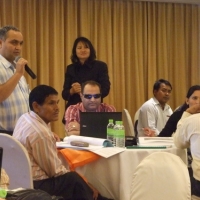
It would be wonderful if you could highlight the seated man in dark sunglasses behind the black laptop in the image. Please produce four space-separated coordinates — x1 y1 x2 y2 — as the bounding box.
65 81 116 135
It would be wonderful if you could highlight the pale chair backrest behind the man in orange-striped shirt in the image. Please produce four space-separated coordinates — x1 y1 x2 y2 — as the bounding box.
0 133 33 189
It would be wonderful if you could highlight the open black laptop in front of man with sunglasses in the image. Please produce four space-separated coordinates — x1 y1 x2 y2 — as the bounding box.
80 112 122 139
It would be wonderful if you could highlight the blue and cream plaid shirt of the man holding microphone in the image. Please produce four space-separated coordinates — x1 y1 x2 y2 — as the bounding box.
0 55 30 131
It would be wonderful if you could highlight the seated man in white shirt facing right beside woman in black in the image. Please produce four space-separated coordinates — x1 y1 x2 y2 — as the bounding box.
137 79 172 137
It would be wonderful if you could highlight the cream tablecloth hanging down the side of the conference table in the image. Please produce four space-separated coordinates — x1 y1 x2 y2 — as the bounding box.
76 147 187 200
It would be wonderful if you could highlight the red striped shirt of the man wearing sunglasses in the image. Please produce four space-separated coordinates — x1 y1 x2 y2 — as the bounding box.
65 103 116 129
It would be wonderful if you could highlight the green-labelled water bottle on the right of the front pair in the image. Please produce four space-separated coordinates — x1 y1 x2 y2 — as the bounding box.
115 121 125 148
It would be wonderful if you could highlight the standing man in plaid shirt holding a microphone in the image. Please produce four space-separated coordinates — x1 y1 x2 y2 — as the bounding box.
0 26 30 135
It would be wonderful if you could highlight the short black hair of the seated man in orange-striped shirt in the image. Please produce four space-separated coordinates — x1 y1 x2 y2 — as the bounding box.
29 85 58 111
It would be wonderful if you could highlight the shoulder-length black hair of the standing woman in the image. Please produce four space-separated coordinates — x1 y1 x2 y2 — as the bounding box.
71 37 96 63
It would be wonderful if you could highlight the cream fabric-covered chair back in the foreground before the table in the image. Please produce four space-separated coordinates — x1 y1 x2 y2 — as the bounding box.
130 152 191 200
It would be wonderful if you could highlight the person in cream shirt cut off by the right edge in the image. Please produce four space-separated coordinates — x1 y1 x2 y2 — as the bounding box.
173 104 200 197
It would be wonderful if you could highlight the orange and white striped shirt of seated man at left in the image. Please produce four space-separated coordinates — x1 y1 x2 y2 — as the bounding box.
13 111 68 181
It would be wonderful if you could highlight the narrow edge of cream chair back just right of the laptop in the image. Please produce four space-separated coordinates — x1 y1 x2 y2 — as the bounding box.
122 109 135 136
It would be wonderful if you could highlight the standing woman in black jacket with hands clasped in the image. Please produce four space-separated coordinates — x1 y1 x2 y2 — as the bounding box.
62 37 110 118
